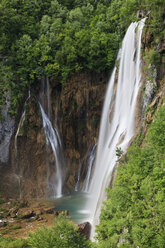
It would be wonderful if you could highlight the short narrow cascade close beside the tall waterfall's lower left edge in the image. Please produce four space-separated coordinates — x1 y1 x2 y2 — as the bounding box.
82 144 97 192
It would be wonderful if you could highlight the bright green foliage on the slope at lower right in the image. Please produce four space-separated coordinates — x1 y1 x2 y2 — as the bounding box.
97 106 165 248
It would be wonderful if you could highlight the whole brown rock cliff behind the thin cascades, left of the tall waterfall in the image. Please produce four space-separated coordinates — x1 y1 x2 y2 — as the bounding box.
0 71 108 198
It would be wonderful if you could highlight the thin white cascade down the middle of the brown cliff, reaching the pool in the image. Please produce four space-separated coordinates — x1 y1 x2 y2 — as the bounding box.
39 103 62 197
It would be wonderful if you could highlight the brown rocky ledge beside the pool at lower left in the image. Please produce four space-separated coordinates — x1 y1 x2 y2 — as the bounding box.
0 199 68 238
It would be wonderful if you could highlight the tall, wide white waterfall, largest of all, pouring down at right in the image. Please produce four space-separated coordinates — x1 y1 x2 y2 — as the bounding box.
87 19 145 235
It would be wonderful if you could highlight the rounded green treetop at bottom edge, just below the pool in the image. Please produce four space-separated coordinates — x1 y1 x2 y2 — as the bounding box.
28 216 91 248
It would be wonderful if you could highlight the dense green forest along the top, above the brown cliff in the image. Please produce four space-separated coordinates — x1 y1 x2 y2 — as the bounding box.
0 0 164 114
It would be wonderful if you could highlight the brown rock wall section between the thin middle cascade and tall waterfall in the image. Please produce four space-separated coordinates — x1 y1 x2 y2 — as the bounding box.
55 71 108 190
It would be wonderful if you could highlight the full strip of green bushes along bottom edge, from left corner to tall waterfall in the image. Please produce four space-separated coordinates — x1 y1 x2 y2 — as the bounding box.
0 215 91 248
